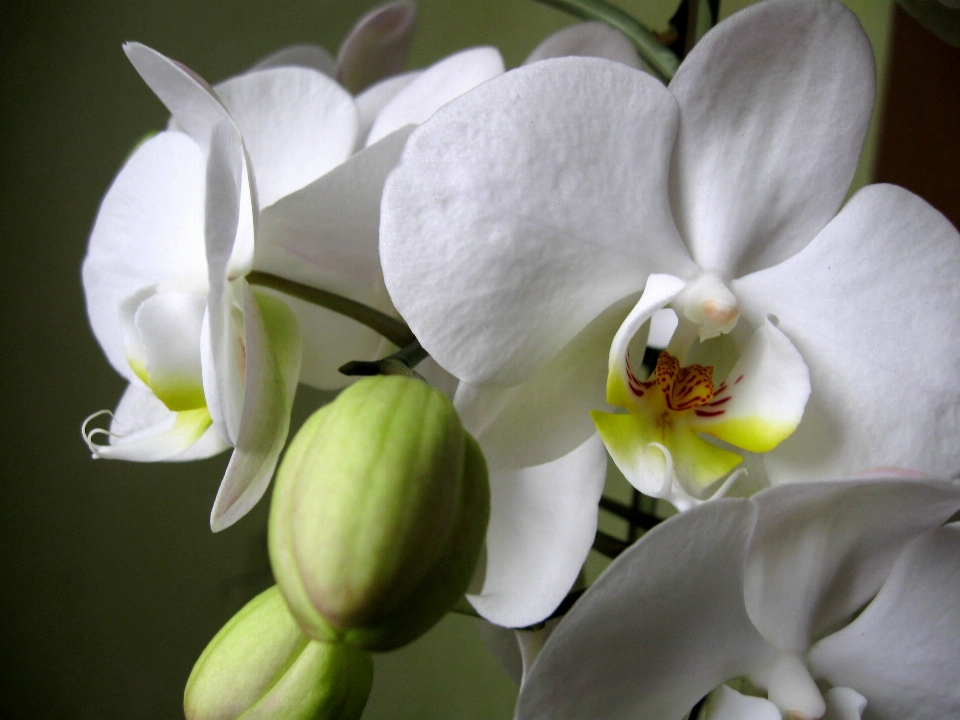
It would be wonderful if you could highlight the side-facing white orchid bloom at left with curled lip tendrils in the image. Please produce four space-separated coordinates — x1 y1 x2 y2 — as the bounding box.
83 3 503 530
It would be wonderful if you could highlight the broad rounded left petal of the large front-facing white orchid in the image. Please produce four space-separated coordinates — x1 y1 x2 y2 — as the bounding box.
380 58 694 384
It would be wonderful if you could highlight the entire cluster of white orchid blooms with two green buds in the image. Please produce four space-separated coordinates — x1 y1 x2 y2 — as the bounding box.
83 0 960 720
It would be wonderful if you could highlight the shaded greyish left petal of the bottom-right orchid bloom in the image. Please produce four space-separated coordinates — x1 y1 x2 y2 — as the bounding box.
517 500 769 720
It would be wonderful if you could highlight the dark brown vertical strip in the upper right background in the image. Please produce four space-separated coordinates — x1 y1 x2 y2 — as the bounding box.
876 6 960 227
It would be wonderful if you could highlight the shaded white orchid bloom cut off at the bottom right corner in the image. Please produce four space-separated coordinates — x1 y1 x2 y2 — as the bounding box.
517 477 960 720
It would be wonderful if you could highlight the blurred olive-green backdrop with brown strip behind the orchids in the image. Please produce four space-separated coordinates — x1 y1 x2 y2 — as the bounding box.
0 0 960 720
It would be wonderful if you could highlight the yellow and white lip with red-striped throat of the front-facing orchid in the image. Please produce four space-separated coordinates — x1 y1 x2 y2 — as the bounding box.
590 273 810 509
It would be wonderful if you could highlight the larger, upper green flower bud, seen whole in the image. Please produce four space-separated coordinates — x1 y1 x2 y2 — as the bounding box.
270 376 490 650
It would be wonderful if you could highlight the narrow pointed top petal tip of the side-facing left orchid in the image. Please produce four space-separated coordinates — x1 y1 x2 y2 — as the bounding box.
123 42 230 152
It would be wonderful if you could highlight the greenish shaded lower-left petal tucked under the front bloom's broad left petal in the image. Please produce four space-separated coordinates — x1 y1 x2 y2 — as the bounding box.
455 298 632 471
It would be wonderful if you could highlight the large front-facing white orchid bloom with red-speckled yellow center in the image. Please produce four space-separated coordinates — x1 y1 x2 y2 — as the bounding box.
380 0 960 625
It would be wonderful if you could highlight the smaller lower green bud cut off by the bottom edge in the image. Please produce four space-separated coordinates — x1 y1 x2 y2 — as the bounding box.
183 586 373 720
